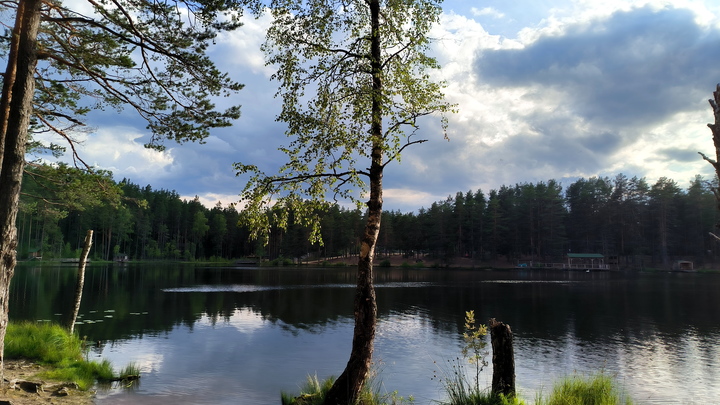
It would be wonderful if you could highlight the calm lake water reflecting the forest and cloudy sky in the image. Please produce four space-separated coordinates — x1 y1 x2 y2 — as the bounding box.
10 264 720 405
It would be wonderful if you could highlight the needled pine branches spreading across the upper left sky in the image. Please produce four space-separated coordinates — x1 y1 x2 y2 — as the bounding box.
0 0 250 158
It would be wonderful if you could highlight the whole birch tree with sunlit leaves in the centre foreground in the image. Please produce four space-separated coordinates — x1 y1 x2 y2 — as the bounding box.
236 0 452 404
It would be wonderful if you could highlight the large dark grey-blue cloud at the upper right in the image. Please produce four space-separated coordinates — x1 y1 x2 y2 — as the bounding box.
474 7 720 126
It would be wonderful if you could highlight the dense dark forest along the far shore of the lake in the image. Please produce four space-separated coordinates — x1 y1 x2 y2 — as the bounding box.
17 166 720 267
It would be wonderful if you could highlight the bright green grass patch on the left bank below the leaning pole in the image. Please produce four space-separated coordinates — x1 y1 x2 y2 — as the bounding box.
5 322 139 390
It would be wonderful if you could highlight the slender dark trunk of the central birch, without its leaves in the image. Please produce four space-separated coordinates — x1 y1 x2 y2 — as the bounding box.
325 0 384 405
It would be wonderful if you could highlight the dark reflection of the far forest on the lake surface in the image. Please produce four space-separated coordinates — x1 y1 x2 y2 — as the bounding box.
10 264 720 347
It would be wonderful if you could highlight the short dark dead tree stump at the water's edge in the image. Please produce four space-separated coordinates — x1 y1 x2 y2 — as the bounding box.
488 318 515 396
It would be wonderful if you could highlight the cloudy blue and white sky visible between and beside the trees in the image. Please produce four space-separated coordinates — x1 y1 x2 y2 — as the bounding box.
64 0 720 212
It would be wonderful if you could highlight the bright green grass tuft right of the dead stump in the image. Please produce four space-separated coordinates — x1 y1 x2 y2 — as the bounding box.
535 373 632 405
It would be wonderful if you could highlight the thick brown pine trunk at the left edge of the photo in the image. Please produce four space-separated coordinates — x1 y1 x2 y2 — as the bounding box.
0 0 42 381
